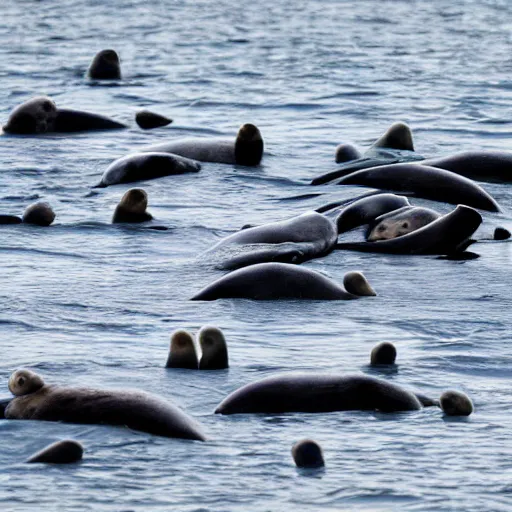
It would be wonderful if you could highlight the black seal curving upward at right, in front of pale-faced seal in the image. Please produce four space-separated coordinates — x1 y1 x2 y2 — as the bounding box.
336 205 482 255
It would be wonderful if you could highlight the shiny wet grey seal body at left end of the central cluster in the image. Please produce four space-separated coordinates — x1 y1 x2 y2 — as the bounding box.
206 212 338 270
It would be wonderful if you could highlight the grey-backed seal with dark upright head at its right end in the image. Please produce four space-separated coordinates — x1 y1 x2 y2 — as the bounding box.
143 124 263 166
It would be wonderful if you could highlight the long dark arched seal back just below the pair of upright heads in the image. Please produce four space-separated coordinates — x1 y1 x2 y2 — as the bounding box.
215 373 436 414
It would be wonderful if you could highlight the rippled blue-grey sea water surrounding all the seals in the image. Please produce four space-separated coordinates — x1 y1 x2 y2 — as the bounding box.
0 0 512 511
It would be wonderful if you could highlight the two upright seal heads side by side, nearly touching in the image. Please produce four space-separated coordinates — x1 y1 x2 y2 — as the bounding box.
165 326 229 370
